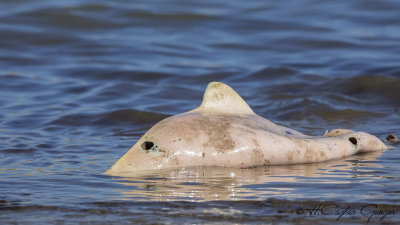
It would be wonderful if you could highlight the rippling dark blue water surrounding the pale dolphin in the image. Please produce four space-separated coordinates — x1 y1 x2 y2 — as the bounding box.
0 0 400 224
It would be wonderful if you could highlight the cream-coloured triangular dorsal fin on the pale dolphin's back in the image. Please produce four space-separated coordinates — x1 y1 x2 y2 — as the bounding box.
193 82 254 114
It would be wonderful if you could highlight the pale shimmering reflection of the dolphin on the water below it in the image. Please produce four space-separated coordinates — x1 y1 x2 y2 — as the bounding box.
113 152 382 202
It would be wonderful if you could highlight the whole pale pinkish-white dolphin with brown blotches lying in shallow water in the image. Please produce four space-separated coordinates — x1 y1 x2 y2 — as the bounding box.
107 82 387 174
